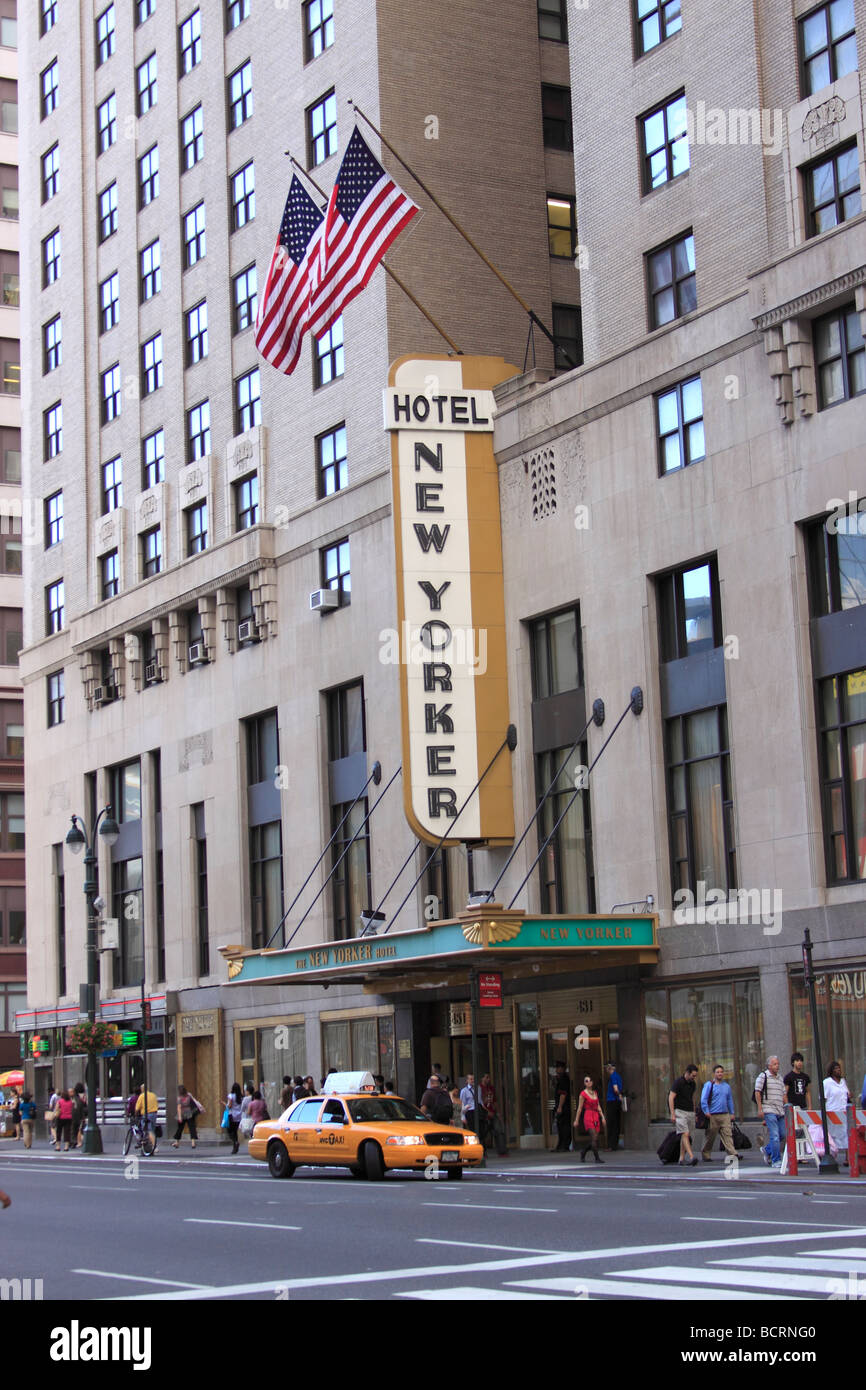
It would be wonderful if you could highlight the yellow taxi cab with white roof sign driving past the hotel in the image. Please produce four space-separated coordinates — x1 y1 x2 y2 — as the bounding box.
249 1072 484 1182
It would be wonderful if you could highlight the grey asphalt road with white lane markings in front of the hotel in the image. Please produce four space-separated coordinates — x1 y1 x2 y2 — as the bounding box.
0 1152 866 1301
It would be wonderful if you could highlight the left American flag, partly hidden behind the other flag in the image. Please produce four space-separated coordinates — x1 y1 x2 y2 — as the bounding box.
256 174 324 375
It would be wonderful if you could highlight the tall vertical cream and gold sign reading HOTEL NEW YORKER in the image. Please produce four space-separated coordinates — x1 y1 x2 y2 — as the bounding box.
385 357 516 844
